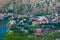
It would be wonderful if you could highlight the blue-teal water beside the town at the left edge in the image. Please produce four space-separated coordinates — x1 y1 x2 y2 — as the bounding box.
0 19 8 40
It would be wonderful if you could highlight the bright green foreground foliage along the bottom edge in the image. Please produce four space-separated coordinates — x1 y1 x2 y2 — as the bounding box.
5 31 60 40
